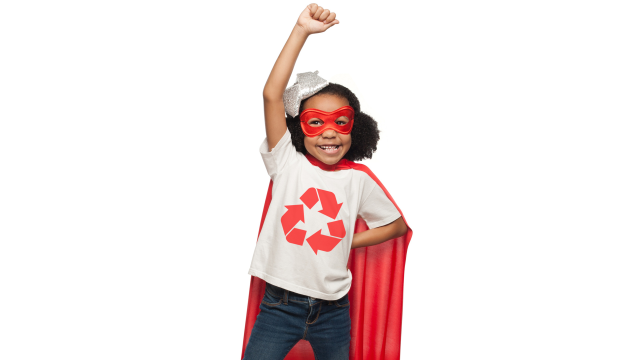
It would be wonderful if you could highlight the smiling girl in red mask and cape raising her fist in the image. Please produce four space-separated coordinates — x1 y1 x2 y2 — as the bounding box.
242 4 412 360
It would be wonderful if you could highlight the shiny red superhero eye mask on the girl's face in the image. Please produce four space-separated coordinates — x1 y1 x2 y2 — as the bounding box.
300 105 355 137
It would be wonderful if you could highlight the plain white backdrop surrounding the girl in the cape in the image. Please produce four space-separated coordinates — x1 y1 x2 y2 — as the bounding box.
0 0 640 360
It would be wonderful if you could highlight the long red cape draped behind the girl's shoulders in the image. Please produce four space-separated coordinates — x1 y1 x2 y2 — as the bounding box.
241 154 413 360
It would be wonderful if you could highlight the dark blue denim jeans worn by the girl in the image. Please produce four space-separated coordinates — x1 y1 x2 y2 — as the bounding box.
242 283 351 360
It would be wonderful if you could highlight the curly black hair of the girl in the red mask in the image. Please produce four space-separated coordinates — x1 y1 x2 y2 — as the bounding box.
287 83 380 161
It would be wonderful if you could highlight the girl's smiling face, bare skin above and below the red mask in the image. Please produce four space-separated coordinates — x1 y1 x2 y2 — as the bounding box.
300 94 351 165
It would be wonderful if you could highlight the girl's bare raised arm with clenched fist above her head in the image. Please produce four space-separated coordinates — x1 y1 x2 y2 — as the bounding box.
262 4 339 151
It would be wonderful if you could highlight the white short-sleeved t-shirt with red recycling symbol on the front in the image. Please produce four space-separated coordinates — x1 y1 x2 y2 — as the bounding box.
249 129 401 300
